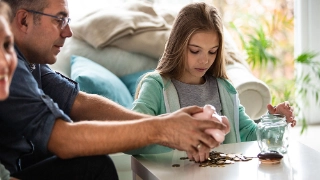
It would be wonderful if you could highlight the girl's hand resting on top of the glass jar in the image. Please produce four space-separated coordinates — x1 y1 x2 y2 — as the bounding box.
267 101 297 127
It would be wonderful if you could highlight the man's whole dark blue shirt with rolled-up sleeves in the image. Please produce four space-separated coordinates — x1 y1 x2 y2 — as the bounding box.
0 47 79 173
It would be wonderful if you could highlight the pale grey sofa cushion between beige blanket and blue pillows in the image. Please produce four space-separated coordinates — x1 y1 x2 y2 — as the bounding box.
50 37 158 77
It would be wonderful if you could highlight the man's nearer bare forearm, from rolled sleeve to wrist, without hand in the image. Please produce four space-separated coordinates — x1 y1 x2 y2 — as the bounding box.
48 119 161 158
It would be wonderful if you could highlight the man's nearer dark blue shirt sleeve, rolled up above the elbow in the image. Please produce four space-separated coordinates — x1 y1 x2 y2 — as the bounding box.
0 60 72 154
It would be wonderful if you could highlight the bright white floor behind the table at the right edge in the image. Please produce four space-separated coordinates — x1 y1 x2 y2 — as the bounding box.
289 124 320 152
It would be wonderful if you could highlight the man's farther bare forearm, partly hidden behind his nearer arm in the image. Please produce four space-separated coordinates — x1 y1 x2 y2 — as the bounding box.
70 92 149 121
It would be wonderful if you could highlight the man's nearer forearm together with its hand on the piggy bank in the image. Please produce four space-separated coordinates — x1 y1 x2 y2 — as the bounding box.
48 106 226 158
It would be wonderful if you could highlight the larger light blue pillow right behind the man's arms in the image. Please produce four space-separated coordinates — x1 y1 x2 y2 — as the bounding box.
71 56 133 109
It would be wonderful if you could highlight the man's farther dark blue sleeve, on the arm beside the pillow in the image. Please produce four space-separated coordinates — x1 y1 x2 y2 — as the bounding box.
40 65 79 115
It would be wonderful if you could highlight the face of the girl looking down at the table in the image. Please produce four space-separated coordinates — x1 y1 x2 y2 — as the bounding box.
179 31 219 84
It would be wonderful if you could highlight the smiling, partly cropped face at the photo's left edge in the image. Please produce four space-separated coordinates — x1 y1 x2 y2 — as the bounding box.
0 15 17 100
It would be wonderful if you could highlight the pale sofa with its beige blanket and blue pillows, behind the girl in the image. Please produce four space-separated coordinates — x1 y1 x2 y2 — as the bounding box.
50 2 271 179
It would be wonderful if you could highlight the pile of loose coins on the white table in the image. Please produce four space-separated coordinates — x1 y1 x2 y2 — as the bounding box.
173 151 253 167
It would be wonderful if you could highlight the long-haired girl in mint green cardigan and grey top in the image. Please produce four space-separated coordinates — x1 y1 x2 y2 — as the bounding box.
129 3 295 161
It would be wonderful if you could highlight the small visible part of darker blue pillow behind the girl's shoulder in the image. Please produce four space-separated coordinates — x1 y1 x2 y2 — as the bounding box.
120 70 154 98
